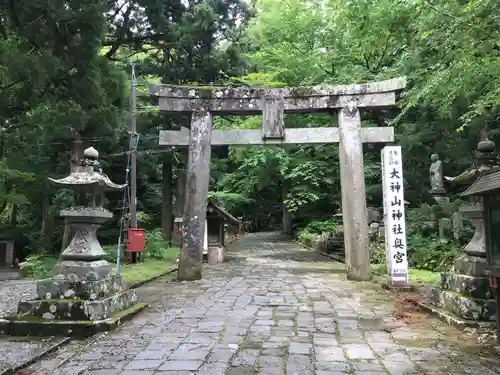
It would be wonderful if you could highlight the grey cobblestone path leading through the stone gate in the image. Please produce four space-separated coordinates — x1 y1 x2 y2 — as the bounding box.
19 233 500 375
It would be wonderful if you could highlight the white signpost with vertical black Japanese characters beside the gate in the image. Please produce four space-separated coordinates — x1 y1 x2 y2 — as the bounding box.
382 146 408 286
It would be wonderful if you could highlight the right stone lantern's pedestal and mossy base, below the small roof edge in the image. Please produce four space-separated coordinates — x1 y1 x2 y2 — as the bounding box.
427 202 497 322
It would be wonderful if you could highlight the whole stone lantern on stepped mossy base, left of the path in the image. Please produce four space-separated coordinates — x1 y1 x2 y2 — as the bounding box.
0 147 146 335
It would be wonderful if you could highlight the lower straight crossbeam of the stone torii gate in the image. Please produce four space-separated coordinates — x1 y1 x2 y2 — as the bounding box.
159 127 394 146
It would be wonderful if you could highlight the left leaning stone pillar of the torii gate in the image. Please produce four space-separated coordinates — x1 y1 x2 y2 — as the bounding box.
177 109 212 281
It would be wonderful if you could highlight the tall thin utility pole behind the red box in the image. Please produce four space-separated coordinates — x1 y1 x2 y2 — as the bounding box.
130 63 139 228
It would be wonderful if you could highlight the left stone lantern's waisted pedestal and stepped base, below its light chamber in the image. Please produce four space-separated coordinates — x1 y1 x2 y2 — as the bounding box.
0 208 146 336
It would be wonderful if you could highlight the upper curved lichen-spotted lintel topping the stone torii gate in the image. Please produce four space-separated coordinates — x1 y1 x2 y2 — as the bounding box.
149 78 406 116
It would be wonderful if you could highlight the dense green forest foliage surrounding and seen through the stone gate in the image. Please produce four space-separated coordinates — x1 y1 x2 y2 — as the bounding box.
0 0 500 276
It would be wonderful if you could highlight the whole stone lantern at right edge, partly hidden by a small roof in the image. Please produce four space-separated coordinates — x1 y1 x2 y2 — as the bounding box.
428 136 497 321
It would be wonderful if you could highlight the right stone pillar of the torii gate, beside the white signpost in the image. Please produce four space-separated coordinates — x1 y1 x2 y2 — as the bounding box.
338 107 371 281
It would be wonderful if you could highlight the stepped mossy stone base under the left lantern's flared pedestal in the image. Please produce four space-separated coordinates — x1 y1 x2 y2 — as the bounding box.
0 277 146 336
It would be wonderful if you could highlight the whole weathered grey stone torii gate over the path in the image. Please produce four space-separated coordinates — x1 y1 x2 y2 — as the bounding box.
150 78 406 280
